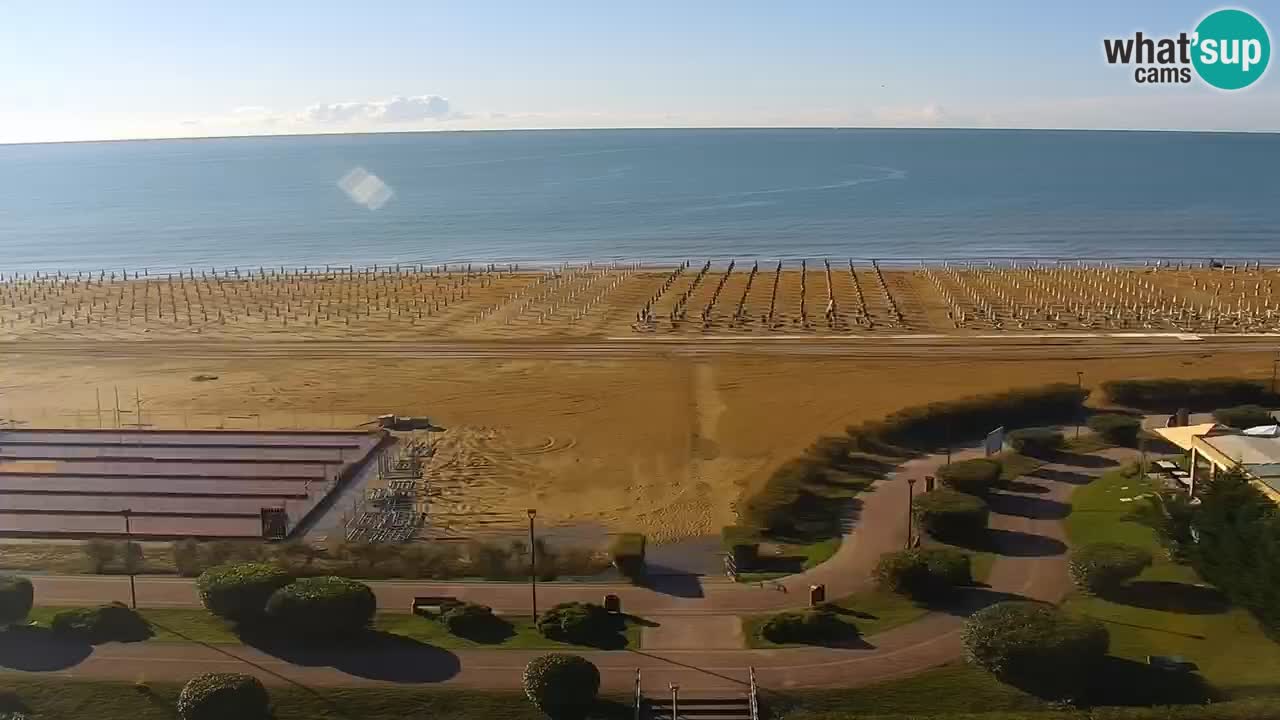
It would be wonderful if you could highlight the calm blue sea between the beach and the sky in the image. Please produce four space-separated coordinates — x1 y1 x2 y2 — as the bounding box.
0 129 1280 272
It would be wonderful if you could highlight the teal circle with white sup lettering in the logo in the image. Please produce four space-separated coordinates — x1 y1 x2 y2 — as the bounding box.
1192 10 1271 90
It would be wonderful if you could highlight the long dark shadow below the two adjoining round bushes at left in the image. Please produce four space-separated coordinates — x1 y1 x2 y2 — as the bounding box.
241 630 461 684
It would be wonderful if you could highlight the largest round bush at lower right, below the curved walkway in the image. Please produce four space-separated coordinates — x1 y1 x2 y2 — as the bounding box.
960 601 1110 694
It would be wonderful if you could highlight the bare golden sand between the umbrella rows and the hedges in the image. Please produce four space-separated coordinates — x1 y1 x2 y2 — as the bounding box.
0 345 1270 539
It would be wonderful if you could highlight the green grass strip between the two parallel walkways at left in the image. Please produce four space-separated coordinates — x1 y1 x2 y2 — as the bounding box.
29 607 641 650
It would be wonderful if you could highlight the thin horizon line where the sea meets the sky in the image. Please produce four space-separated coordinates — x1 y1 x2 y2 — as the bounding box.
0 126 1280 147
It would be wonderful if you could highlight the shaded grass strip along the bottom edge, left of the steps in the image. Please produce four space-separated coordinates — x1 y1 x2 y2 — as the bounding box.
5 676 631 720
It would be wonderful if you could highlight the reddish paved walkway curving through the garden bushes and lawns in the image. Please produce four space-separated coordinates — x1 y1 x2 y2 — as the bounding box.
0 450 1135 692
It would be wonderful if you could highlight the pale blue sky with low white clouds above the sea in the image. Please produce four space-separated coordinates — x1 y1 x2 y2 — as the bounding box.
0 0 1280 142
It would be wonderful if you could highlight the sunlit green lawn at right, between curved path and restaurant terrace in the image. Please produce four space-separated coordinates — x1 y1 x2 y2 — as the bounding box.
1065 471 1280 697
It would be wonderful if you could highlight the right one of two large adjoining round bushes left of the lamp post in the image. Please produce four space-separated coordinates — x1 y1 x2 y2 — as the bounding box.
266 575 378 642
